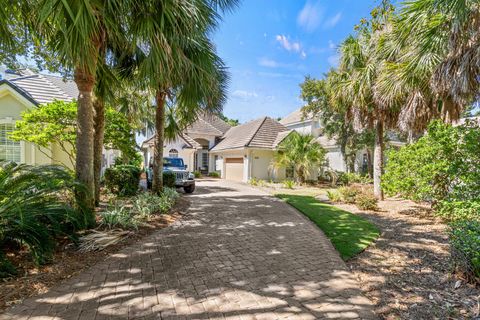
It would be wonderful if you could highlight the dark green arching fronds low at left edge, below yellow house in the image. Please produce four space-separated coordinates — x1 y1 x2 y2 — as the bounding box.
0 162 85 264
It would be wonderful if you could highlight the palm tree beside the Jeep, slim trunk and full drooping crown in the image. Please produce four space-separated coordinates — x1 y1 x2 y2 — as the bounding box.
131 0 237 193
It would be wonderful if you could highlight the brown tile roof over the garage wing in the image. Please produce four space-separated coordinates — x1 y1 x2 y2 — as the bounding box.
211 117 288 151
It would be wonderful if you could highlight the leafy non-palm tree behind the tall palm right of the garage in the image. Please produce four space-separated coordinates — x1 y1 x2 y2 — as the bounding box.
300 75 373 172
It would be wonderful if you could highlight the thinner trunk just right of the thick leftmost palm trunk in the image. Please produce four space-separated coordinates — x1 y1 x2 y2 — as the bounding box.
93 97 105 205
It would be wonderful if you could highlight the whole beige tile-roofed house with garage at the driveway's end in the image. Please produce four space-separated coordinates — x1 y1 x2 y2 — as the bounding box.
142 115 289 182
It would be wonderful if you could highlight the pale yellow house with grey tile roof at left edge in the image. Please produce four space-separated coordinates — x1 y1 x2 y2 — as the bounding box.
0 67 118 168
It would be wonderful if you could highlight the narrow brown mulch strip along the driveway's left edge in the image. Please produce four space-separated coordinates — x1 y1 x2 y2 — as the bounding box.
0 197 190 311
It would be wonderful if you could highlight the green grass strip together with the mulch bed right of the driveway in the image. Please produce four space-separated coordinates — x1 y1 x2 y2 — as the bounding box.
253 182 480 319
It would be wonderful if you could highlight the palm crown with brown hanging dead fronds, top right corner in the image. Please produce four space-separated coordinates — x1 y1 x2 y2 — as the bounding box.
397 0 480 115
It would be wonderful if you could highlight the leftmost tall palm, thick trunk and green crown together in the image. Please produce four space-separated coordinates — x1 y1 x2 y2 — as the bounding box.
31 0 130 209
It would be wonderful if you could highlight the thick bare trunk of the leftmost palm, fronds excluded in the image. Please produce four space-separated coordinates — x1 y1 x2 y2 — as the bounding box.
74 68 95 219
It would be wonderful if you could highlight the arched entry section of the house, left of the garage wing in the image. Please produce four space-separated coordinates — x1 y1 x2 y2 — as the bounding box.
142 114 230 174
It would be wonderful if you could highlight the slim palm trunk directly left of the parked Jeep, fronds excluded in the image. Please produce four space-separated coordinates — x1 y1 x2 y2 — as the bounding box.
152 89 167 194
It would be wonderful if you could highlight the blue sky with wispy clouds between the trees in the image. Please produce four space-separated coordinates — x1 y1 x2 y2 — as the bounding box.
214 0 376 123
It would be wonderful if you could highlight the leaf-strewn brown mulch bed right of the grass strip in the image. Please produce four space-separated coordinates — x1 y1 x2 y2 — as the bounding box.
338 199 480 320
